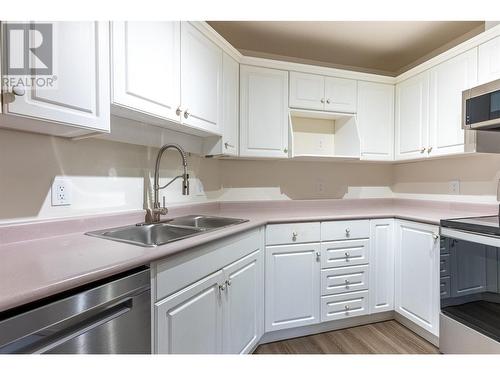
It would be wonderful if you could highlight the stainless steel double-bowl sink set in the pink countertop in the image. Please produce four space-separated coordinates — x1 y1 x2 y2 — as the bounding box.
85 215 248 247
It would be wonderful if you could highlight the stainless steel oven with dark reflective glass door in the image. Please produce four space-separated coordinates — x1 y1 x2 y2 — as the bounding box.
439 216 500 354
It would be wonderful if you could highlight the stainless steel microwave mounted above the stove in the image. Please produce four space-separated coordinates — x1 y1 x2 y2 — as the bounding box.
462 79 500 131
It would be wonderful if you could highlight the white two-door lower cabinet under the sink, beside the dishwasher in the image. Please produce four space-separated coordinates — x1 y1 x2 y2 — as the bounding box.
152 229 264 354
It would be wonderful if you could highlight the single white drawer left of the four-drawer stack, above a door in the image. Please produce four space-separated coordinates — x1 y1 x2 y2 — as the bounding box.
266 223 321 245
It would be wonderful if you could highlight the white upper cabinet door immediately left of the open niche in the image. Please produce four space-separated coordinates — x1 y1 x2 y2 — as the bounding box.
240 65 288 158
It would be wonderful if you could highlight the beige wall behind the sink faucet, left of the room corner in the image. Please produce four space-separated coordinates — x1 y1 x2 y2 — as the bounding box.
0 130 220 222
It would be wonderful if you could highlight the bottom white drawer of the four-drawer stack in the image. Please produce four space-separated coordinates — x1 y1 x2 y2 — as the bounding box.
321 290 368 322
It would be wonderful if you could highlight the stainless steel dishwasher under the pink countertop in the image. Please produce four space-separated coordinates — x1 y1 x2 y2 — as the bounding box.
0 267 151 354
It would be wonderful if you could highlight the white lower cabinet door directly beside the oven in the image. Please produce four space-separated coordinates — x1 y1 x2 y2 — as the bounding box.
395 221 440 336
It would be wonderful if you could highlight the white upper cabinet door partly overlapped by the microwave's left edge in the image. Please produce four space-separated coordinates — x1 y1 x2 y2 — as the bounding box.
427 48 477 156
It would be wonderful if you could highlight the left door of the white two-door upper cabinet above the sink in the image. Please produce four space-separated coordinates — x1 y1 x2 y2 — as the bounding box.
111 21 181 121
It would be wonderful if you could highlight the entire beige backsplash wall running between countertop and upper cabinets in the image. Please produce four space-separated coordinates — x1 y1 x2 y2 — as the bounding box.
0 130 500 223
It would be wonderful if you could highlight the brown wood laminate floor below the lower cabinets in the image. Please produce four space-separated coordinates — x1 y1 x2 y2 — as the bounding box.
254 320 439 354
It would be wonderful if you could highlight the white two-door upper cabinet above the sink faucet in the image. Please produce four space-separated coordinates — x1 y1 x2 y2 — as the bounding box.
112 22 222 136
